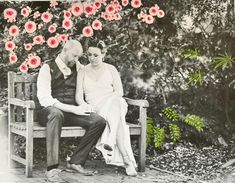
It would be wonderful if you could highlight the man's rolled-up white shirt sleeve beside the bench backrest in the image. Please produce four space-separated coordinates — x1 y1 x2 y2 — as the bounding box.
37 64 59 107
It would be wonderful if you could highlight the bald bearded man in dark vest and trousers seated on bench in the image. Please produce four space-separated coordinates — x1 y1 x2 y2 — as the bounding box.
37 40 106 183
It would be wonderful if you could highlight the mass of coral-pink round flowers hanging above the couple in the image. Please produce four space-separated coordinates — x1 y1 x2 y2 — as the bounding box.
3 0 164 72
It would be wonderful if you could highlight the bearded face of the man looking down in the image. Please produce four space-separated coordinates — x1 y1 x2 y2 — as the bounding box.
65 48 82 68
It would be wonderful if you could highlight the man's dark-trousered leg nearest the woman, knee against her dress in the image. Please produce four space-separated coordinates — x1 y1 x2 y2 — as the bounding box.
64 113 106 166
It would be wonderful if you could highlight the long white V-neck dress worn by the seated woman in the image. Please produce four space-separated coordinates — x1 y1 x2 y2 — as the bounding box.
83 64 137 167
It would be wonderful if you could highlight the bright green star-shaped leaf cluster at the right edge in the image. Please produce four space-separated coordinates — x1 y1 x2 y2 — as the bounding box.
213 53 234 70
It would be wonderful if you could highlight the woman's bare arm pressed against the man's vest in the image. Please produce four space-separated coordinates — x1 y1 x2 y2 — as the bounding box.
75 68 86 105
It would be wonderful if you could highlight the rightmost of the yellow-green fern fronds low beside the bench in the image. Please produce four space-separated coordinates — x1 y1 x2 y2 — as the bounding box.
184 114 205 132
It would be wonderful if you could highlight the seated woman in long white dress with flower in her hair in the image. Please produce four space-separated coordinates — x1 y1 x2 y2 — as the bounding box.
76 41 137 176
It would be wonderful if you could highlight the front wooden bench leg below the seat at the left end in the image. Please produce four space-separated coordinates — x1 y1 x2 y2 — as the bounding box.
25 137 33 177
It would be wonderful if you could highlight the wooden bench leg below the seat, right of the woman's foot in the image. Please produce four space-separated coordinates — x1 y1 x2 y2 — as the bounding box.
138 136 146 172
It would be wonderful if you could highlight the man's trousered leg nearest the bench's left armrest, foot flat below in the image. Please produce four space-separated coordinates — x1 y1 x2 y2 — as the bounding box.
39 107 64 171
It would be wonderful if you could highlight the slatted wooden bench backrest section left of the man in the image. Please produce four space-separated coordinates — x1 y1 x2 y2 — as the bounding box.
8 72 40 122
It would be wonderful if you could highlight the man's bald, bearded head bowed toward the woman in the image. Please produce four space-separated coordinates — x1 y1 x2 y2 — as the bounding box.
61 40 83 68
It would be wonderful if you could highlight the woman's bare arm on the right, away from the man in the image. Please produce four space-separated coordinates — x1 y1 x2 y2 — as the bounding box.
110 65 123 97
